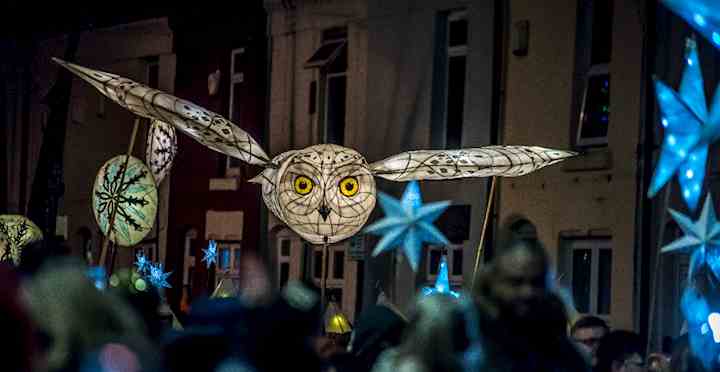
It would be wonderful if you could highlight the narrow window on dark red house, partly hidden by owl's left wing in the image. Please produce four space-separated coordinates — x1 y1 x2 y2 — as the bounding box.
225 48 246 177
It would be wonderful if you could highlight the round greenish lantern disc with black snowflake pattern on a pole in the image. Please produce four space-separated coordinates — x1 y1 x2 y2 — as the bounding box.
92 155 158 247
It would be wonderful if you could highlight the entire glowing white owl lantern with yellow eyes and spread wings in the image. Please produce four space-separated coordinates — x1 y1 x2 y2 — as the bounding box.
53 58 577 244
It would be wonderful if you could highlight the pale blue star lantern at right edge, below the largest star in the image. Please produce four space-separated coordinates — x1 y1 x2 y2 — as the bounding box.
661 194 720 279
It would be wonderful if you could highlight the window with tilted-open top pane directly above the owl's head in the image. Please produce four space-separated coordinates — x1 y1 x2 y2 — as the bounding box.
305 27 348 145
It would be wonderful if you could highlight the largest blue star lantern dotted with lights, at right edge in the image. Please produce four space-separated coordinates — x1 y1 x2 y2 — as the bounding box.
648 40 720 210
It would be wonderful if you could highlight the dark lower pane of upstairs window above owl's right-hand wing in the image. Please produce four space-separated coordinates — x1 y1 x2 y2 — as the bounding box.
445 56 465 149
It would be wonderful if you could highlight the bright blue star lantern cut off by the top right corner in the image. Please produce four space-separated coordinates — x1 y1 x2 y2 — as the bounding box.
661 0 720 48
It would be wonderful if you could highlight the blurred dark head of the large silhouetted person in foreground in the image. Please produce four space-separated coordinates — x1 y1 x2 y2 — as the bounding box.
484 240 549 317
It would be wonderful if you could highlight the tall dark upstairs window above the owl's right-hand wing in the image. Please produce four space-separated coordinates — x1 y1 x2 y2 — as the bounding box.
431 10 469 149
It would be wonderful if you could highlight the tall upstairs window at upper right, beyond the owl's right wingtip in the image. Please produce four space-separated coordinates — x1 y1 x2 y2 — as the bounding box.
572 0 613 147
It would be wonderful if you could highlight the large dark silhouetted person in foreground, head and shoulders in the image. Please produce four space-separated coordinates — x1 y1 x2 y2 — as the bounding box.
475 240 589 372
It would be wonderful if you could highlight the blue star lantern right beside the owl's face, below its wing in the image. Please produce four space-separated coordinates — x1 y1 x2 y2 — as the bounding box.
365 181 450 271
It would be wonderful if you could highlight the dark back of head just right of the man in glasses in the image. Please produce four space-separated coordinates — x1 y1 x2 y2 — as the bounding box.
596 331 645 372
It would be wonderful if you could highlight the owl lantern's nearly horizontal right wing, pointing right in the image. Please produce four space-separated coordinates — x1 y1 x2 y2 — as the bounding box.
370 146 577 182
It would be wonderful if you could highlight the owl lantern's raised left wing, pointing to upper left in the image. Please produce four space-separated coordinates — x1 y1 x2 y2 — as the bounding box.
53 58 269 165
